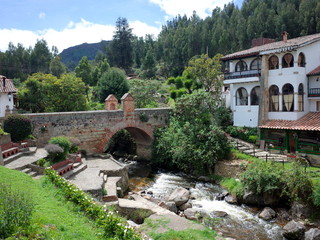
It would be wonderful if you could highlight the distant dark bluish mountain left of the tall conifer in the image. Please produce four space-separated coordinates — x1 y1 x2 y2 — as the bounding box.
60 41 110 71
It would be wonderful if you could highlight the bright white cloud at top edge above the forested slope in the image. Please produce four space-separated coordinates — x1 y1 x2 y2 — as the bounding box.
149 0 230 18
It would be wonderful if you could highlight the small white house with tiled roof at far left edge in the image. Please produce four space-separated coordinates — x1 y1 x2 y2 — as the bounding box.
0 75 17 117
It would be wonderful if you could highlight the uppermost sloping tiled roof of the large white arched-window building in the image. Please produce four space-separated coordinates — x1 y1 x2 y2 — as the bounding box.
221 33 320 60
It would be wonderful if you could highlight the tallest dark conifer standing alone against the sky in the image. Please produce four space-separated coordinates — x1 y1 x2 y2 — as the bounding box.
107 17 133 71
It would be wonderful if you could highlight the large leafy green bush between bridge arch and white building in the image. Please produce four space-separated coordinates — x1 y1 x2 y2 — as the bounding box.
153 91 230 174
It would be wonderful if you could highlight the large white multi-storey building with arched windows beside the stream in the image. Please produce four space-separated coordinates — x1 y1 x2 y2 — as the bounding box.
222 32 320 154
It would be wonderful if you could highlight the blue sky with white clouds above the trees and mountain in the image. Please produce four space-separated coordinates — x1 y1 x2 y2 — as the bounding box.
0 0 242 52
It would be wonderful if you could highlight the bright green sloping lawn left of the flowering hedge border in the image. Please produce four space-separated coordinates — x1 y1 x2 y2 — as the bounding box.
0 166 103 240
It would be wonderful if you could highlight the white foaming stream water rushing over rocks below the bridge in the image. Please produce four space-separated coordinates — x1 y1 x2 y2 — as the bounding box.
129 161 283 240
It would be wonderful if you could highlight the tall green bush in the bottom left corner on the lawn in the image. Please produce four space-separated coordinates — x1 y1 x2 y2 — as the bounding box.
0 183 34 239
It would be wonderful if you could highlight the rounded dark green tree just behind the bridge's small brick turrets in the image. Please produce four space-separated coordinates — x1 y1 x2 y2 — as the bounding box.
95 68 129 103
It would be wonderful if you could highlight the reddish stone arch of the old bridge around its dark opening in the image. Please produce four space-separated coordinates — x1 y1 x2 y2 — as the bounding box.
98 125 153 159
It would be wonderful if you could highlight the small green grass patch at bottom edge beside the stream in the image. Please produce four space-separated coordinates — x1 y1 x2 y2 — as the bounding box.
151 229 217 240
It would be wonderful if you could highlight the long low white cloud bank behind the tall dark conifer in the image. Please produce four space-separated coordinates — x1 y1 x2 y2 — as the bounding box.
0 19 161 52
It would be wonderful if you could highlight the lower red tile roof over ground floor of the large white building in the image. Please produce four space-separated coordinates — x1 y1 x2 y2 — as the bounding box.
259 112 320 131
